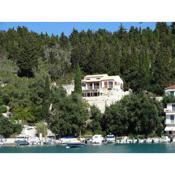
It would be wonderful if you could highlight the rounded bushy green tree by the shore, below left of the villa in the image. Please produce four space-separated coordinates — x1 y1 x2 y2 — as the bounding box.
48 89 89 137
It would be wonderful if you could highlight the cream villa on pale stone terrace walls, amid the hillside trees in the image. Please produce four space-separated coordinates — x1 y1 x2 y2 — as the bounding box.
63 74 129 113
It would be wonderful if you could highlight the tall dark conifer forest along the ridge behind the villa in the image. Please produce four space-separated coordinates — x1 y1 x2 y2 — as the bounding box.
0 22 175 95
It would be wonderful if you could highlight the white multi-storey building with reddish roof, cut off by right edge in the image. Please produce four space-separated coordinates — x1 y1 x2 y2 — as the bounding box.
164 85 175 136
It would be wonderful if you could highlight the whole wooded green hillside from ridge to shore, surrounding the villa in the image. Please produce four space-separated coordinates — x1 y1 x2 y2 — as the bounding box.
0 22 175 136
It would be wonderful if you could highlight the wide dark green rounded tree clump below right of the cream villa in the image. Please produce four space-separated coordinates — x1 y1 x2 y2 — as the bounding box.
103 93 163 136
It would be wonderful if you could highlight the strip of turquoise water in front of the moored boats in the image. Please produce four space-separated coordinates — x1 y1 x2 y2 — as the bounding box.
0 144 175 153
